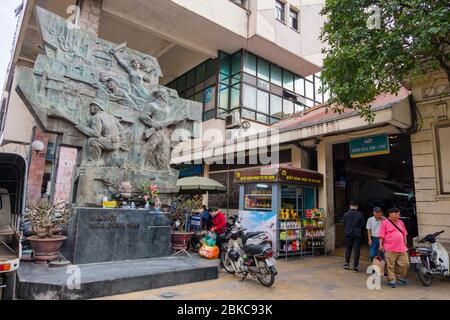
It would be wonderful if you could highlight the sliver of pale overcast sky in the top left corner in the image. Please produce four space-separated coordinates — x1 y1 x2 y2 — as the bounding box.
0 0 22 92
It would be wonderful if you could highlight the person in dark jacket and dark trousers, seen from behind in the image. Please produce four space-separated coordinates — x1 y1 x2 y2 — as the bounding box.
344 201 365 272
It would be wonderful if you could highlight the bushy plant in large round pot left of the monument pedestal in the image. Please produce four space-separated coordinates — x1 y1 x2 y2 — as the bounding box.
25 199 72 263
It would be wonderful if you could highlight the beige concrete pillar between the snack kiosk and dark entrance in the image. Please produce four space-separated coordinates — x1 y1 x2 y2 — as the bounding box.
317 141 336 250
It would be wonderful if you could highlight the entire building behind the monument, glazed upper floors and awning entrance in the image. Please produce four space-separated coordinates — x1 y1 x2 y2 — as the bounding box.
0 0 450 255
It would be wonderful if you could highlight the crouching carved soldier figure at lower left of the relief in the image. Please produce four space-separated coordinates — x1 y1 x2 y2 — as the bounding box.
76 101 125 165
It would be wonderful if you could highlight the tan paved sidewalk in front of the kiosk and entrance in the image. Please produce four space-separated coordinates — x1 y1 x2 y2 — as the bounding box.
98 256 450 300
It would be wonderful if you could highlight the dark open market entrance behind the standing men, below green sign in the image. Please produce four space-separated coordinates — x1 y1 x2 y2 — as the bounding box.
333 134 418 247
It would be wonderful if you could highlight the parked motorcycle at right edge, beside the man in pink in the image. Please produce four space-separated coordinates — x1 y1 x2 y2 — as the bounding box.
409 230 449 287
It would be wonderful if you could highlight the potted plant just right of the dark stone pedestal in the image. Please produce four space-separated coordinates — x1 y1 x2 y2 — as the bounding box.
170 196 202 250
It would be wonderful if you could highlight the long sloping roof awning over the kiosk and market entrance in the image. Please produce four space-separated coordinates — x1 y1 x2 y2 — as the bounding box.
171 88 411 164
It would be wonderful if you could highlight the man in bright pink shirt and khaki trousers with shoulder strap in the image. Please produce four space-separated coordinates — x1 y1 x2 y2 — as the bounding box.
378 208 409 288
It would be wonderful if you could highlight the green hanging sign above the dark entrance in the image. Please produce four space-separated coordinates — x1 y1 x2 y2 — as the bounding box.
349 134 390 158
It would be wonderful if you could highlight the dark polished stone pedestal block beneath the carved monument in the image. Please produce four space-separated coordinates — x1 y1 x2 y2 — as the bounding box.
61 208 171 264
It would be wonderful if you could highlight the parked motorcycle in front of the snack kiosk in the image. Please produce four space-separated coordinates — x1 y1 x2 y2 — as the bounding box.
220 225 278 287
